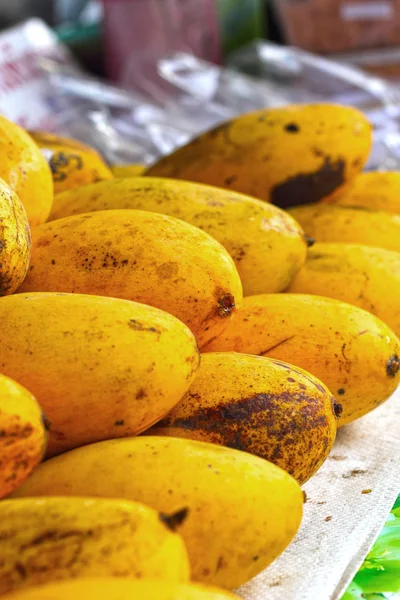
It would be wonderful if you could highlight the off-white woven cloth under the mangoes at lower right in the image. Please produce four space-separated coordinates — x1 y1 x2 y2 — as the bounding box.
238 389 400 600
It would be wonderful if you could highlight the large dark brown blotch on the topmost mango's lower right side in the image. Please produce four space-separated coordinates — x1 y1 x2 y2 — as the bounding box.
271 157 346 208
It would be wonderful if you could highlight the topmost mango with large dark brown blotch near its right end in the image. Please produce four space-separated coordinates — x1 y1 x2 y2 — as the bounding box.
144 104 372 208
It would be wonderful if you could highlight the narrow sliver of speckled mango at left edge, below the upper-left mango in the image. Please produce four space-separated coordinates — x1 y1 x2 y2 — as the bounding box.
0 179 31 296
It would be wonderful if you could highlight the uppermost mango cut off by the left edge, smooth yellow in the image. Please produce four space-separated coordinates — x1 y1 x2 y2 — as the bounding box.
0 115 53 227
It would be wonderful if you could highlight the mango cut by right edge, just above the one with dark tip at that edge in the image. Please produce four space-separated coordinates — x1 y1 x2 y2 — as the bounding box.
287 242 400 336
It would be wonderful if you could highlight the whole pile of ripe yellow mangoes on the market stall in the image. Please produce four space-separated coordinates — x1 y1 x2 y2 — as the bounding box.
0 105 400 600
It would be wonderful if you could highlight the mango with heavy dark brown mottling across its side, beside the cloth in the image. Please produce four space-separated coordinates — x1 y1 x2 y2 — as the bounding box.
149 352 336 483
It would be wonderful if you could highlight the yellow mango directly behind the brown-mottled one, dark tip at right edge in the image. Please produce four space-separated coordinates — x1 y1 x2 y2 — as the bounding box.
204 294 400 427
